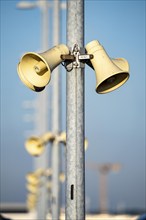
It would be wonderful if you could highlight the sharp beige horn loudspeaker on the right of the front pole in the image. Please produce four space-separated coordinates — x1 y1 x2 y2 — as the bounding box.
85 40 129 94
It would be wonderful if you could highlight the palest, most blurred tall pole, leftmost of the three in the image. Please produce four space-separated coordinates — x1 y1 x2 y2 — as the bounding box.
35 0 51 220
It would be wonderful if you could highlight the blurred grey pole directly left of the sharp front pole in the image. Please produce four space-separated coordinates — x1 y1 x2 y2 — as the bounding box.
52 0 61 220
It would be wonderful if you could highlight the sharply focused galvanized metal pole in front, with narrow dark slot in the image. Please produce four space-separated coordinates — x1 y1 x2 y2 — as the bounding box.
66 0 85 220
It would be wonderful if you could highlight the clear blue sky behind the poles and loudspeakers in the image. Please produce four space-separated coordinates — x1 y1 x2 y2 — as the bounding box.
1 0 146 213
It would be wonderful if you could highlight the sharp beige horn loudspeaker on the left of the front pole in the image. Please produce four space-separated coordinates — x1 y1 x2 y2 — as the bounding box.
17 44 69 92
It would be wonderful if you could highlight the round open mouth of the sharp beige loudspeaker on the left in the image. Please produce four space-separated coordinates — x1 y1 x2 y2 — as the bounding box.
18 52 51 88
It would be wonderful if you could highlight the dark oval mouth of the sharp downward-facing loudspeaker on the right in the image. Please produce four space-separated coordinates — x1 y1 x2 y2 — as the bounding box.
96 72 129 94
